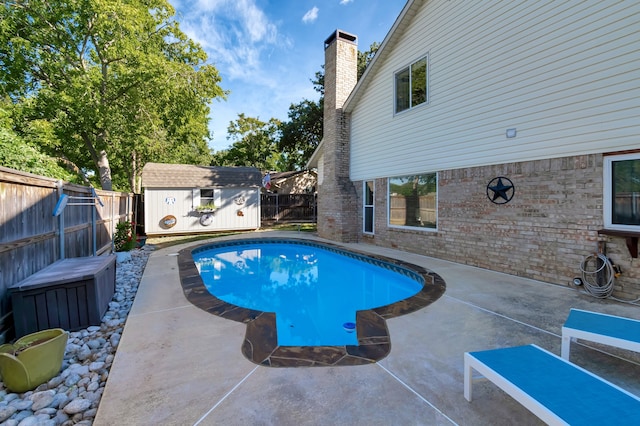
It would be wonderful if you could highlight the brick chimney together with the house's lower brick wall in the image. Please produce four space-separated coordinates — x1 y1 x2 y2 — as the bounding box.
318 31 640 300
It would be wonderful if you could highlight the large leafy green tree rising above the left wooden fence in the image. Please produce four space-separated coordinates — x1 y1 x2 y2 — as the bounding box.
0 0 225 190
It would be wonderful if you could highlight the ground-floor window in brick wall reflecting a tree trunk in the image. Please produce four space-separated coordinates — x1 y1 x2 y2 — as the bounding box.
389 173 438 229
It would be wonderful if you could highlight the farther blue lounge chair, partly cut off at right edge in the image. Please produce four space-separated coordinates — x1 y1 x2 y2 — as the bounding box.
560 309 640 360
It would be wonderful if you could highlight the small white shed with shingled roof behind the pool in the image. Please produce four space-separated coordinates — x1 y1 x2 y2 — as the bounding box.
142 163 262 235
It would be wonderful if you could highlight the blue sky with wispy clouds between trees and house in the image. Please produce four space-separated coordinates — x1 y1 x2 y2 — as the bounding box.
169 0 406 151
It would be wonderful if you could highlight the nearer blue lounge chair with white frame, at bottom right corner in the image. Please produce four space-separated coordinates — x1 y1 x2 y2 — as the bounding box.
464 345 640 426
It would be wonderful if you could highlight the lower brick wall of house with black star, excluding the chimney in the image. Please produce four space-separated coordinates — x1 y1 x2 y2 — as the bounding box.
358 155 640 299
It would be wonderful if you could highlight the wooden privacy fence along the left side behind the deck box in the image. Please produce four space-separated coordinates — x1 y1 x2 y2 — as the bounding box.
0 167 133 341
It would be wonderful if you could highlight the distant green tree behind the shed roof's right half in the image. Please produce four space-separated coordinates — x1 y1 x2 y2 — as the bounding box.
211 113 280 171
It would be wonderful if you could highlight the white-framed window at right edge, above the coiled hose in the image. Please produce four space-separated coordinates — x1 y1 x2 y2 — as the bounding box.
603 153 640 231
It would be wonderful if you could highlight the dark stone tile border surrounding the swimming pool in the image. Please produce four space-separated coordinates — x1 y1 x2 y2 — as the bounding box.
178 238 446 367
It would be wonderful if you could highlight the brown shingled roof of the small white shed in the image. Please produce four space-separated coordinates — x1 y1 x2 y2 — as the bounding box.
142 163 262 188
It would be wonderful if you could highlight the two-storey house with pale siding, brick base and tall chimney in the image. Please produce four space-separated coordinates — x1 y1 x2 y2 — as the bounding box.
309 0 640 300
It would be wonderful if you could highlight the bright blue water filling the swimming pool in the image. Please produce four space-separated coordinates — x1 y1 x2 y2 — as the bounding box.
193 242 422 346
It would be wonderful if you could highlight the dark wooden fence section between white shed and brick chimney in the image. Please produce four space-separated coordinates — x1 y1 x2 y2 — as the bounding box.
260 194 318 222
